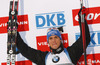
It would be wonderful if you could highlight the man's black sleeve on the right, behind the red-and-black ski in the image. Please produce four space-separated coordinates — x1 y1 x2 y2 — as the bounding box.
67 12 90 64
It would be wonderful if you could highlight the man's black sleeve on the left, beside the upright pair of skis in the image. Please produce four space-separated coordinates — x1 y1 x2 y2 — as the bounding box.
16 32 48 64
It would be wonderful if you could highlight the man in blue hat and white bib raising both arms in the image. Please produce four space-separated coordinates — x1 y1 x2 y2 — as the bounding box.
16 6 90 65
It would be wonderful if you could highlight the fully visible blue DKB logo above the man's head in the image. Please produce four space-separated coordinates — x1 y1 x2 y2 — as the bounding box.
35 11 65 29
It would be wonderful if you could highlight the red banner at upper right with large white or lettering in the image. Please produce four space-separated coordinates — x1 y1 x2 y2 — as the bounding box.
72 7 100 26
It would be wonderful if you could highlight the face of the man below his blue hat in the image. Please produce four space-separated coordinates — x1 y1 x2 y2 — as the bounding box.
49 35 61 49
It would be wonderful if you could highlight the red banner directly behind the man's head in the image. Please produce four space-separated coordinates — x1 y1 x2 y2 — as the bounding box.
36 33 69 51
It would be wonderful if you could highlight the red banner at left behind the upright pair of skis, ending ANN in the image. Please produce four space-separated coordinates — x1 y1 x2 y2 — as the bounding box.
0 15 29 34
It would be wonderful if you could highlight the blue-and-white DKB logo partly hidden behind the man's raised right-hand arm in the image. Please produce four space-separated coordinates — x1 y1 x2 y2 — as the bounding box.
76 31 100 47
